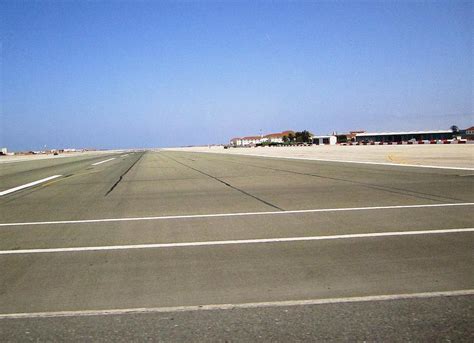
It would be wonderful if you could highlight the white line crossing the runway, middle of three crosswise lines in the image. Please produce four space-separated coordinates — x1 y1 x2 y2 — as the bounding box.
0 228 474 255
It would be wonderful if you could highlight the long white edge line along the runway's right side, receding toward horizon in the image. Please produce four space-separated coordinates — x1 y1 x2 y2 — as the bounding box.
186 150 474 171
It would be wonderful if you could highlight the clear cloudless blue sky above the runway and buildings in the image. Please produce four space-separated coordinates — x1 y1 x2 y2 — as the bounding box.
0 1 474 150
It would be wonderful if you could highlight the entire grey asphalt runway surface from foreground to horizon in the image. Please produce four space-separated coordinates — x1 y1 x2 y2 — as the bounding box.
0 151 474 341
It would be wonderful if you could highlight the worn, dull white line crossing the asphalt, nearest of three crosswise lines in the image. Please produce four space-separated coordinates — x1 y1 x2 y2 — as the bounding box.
0 289 474 319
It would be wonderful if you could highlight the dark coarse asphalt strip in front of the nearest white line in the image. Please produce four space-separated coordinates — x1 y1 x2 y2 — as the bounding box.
0 297 474 342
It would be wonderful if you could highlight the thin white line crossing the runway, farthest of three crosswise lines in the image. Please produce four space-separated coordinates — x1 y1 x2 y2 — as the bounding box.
0 202 474 227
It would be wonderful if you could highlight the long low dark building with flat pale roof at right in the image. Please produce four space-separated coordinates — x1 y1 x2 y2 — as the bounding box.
356 130 453 143
